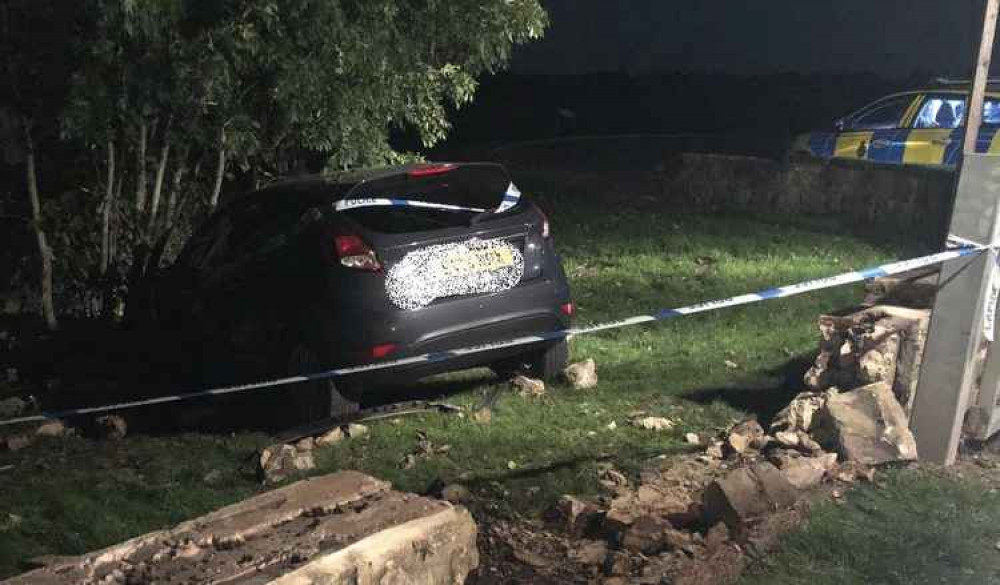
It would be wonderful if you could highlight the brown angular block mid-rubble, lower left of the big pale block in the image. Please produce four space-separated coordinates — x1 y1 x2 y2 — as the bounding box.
704 463 798 529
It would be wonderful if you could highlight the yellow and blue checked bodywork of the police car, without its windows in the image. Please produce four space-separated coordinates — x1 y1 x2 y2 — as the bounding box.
805 90 1000 166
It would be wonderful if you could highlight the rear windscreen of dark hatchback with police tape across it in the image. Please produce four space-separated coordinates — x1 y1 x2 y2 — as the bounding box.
337 164 512 233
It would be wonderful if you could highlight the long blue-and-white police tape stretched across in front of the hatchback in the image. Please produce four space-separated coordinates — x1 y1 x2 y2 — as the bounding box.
0 237 992 427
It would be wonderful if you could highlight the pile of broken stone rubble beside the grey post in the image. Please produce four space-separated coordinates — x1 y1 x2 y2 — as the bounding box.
511 306 929 584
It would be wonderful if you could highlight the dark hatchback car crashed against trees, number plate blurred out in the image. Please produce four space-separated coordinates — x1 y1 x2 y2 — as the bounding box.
147 163 573 420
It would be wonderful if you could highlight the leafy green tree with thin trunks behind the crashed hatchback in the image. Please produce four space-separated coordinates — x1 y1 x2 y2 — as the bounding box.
0 0 546 324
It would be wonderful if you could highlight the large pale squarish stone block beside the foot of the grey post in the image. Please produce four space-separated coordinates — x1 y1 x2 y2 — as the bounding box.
814 382 917 465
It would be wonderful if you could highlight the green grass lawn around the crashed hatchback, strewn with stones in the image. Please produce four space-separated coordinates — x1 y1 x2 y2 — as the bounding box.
0 185 931 583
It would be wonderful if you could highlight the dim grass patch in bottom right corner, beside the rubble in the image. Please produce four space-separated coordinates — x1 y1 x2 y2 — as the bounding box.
740 469 1000 585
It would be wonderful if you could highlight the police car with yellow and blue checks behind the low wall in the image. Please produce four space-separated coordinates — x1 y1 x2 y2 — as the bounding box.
790 79 1000 167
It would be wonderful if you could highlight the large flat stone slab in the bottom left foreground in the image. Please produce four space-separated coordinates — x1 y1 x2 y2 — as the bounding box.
4 471 479 585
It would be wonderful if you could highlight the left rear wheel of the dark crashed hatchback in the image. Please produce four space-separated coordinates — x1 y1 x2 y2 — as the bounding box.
288 343 361 422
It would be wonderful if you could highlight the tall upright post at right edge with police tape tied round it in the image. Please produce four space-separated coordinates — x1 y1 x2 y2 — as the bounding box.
910 0 1000 465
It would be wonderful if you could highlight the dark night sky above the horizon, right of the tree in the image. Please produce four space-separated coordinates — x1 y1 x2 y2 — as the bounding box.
513 0 984 76
